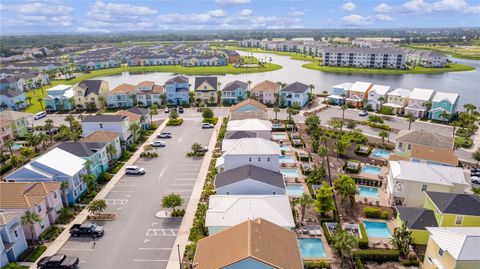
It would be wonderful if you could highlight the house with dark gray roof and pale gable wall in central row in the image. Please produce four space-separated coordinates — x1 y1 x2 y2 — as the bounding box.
215 165 285 195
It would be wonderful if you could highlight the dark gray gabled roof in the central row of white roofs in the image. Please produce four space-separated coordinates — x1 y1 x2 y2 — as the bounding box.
215 164 285 189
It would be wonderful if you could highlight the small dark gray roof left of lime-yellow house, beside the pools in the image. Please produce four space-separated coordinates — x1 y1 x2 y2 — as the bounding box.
396 206 438 230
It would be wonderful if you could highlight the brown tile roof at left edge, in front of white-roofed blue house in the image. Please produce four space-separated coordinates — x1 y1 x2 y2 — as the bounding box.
0 182 60 209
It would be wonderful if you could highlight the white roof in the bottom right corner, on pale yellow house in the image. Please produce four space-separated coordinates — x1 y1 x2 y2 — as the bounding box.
426 227 480 261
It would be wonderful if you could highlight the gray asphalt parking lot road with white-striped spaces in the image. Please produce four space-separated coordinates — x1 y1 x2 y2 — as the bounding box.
59 118 212 269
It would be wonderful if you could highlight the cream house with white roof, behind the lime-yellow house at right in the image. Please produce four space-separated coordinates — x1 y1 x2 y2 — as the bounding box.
387 161 469 207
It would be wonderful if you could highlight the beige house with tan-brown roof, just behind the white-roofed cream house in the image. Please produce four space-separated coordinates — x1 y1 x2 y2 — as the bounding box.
390 130 458 166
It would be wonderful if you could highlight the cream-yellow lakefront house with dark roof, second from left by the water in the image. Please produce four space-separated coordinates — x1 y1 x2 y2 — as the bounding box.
73 80 110 109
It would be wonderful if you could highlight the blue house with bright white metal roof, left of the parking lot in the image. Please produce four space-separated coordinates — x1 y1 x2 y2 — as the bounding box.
5 148 87 203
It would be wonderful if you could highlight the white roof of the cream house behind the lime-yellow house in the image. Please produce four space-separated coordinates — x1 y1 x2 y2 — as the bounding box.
389 161 468 186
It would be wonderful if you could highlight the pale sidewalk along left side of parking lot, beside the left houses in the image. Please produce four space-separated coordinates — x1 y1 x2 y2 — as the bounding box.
30 120 168 269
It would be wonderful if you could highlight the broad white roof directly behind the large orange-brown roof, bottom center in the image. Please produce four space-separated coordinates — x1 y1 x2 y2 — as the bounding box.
205 195 295 227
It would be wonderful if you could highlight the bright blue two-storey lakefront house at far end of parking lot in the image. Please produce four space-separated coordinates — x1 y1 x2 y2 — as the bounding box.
165 76 190 105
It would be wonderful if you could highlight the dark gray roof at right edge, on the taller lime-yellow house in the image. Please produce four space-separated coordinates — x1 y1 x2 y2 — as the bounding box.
427 191 480 216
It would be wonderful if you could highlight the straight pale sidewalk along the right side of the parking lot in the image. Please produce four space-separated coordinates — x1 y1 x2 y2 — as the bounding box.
167 117 223 269
